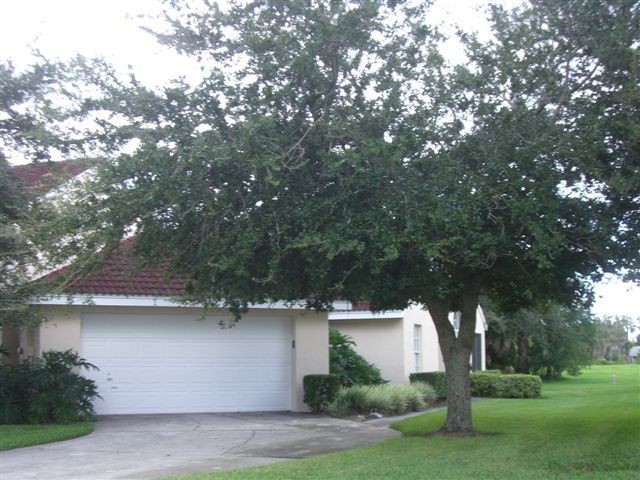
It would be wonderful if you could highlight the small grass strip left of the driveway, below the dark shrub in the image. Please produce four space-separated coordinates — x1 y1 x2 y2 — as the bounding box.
0 422 93 450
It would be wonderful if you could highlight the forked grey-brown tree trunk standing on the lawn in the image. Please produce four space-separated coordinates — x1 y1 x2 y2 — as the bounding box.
427 291 478 435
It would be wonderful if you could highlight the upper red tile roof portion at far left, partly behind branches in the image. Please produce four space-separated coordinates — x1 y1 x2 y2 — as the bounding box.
11 160 93 194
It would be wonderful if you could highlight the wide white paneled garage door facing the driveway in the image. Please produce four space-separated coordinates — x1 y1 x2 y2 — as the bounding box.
82 314 291 415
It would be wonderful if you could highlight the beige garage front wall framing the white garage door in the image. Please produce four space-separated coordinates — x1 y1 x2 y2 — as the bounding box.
31 305 329 411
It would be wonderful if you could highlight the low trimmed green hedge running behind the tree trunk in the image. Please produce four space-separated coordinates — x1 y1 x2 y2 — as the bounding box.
409 372 542 400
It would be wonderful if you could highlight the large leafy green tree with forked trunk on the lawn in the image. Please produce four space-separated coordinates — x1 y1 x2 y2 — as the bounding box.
27 0 640 431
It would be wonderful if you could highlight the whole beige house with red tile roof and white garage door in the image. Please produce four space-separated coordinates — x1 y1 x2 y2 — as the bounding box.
5 159 484 414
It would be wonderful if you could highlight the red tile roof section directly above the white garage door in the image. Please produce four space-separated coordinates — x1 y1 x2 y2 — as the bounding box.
44 241 185 297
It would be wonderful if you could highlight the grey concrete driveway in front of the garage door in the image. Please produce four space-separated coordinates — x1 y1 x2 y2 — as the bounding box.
0 413 399 480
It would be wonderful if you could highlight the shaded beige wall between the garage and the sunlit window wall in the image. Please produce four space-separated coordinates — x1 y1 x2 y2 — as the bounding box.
329 318 408 383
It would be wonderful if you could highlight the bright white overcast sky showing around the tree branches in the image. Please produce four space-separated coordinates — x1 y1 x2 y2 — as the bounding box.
0 0 640 317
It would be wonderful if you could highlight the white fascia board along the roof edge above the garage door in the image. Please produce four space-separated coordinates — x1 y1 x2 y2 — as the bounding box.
33 295 350 310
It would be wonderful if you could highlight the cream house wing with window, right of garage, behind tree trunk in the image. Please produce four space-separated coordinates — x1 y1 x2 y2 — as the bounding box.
329 302 487 383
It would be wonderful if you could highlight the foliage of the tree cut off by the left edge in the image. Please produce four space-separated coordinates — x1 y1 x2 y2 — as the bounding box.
0 62 76 325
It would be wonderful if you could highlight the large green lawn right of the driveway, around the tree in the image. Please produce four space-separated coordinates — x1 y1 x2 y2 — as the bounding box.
166 365 640 480
